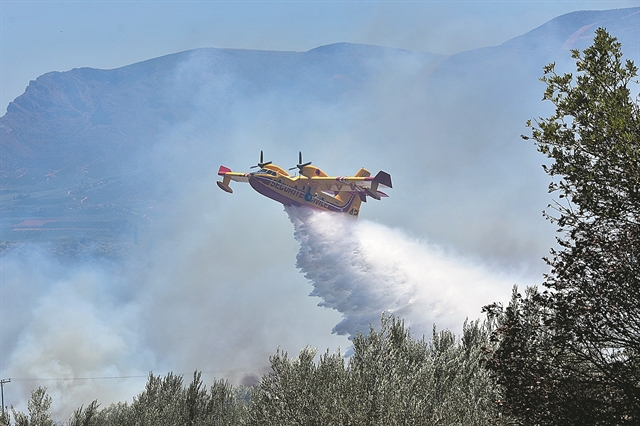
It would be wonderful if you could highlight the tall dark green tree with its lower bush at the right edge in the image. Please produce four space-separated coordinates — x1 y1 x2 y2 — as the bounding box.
486 28 640 424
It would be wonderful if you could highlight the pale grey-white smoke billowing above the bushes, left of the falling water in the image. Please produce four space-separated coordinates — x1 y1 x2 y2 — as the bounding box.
0 196 348 421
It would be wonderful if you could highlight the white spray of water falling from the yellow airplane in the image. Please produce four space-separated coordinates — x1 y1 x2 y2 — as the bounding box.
287 208 525 336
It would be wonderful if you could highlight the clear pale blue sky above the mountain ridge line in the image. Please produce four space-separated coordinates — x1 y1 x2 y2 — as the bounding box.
0 0 640 113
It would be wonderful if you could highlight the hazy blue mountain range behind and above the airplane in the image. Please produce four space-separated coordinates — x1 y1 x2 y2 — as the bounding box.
0 8 640 258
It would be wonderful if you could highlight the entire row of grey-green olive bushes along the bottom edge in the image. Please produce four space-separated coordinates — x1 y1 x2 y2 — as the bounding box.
5 315 499 426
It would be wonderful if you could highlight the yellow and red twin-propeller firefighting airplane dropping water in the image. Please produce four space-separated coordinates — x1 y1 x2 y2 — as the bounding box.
216 151 392 217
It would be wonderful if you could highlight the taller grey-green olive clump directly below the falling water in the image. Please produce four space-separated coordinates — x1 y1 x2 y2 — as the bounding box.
248 316 498 425
